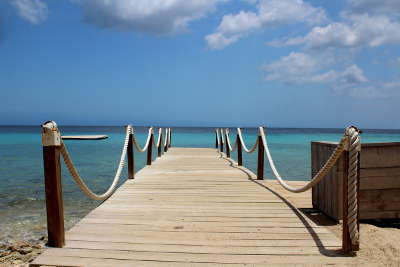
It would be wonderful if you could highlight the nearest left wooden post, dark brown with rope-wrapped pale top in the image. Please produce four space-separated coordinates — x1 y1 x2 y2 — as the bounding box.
42 122 65 248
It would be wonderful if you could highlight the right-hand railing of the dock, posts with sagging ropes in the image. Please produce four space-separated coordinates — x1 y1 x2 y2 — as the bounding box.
215 126 361 252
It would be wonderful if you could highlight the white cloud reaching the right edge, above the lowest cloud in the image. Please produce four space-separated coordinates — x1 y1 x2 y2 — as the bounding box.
276 14 400 49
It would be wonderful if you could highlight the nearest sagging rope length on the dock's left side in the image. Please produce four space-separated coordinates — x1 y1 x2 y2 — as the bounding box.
61 125 132 200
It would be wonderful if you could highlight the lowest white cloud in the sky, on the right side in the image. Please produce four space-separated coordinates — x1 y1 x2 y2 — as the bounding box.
263 52 368 93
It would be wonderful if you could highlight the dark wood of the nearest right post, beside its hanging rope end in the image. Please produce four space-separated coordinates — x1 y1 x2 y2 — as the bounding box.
342 151 352 253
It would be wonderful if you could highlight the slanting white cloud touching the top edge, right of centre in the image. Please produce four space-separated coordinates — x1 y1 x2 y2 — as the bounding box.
205 0 326 49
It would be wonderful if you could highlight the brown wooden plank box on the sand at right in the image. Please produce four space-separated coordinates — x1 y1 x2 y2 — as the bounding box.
311 142 400 220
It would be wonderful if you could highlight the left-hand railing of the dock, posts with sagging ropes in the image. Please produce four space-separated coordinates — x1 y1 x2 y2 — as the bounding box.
42 121 171 247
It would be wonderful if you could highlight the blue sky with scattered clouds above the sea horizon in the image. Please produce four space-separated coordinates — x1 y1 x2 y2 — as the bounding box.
0 0 400 128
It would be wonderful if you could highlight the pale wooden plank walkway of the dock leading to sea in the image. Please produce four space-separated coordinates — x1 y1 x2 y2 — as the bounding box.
30 148 354 266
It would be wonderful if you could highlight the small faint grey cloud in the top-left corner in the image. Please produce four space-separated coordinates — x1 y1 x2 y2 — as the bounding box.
10 0 48 24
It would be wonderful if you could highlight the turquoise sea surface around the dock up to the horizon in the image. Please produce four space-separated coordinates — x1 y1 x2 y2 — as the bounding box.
0 126 400 243
